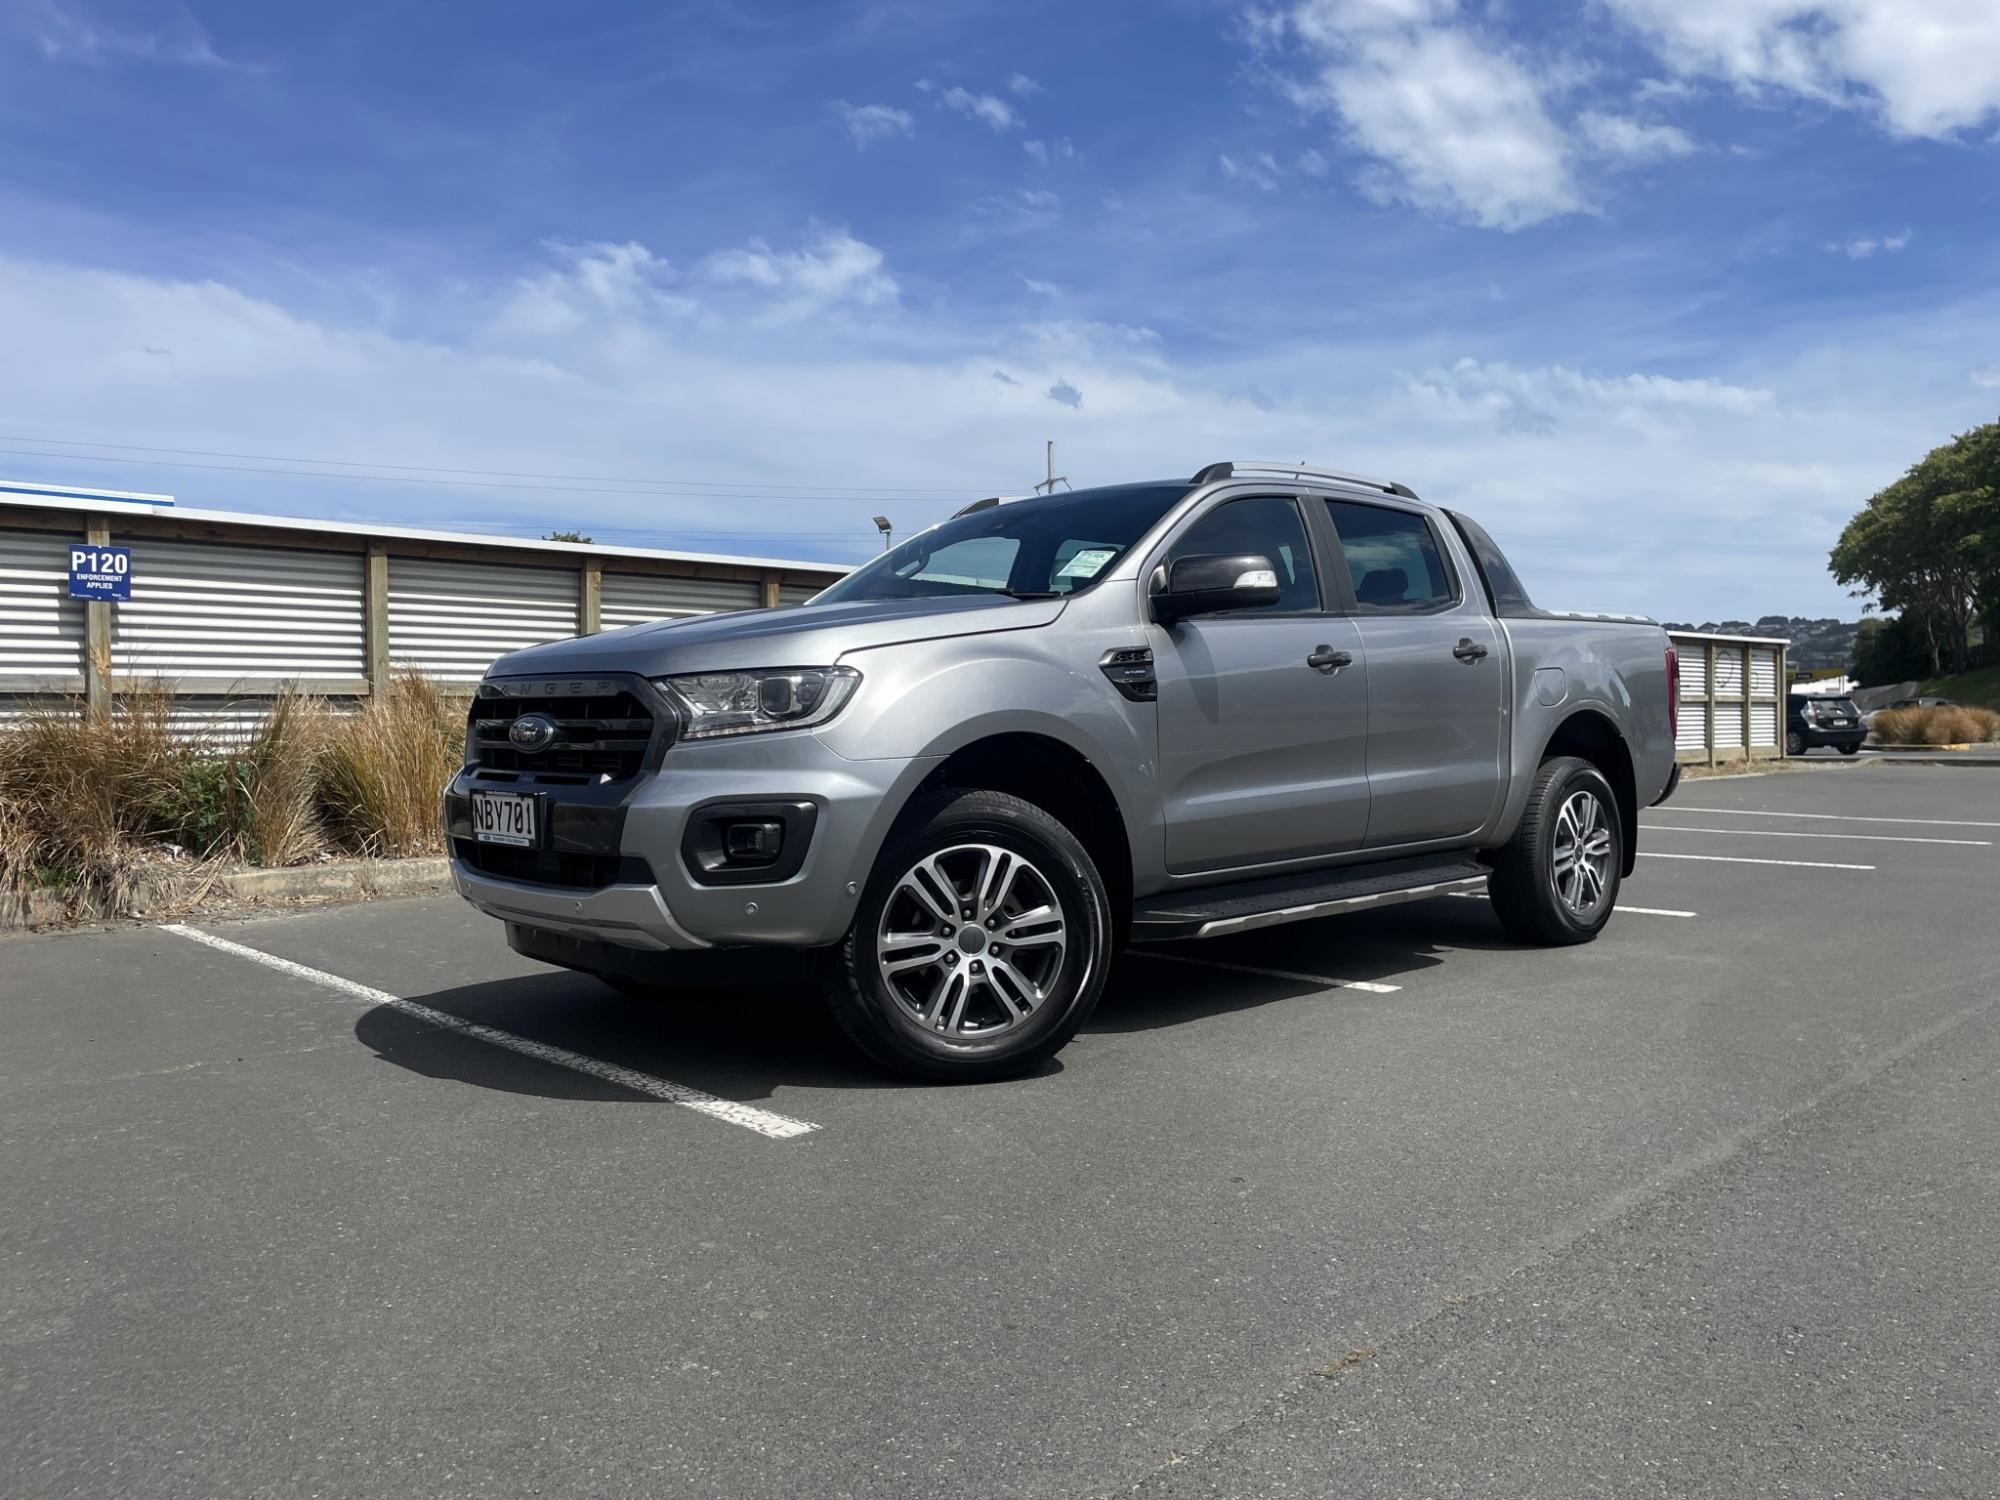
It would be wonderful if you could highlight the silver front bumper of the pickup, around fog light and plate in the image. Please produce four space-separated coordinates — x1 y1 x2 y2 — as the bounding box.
444 732 936 952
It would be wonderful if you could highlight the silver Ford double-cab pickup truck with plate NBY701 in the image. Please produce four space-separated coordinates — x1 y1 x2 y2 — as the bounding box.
444 464 1678 1080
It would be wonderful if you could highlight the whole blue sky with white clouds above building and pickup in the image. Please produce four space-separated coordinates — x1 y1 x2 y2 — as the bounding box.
0 0 2000 620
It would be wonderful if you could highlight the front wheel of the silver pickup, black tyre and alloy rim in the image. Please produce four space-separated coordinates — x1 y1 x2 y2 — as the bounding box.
826 790 1112 1082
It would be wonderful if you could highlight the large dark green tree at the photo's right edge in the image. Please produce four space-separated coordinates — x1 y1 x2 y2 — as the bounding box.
1828 422 2000 676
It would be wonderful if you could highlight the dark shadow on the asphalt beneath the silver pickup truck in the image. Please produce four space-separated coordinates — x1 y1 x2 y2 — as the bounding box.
354 900 1514 1104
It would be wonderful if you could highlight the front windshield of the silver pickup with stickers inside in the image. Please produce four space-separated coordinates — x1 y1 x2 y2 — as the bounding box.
814 480 1188 604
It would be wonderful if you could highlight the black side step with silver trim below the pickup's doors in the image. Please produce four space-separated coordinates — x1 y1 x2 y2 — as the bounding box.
1132 854 1486 942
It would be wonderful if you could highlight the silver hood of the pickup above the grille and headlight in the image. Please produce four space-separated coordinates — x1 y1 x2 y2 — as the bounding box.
490 596 1064 676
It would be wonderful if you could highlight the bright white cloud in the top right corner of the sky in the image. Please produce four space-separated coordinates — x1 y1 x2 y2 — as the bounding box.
1604 0 2000 136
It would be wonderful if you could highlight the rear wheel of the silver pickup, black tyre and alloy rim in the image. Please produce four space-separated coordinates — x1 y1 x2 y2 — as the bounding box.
1486 756 1624 944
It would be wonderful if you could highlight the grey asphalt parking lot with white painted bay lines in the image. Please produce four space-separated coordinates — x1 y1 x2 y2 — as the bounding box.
0 766 2000 1498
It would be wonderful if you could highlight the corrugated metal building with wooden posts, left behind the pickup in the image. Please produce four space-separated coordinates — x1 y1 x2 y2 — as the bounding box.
0 486 846 708
